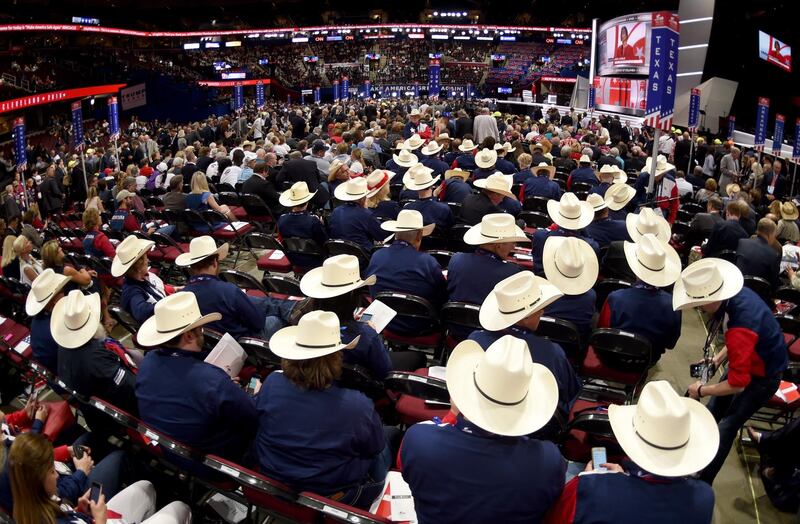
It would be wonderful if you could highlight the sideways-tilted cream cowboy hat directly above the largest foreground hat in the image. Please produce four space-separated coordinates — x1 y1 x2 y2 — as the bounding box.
478 271 564 331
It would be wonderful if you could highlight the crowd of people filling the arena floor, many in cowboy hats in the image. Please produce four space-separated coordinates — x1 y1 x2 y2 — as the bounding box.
0 95 800 524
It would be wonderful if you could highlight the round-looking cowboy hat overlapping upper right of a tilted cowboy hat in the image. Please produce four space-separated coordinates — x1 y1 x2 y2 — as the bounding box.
542 236 600 295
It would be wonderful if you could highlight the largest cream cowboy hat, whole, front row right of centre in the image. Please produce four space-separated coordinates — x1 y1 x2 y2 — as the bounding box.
444 335 558 437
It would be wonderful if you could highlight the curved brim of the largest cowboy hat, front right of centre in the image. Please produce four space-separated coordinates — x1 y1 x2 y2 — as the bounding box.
445 340 558 437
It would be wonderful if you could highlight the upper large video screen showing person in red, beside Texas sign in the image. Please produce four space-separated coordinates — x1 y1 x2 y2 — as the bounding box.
597 13 652 76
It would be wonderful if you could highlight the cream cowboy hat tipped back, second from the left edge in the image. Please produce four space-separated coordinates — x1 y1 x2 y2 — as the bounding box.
50 289 103 349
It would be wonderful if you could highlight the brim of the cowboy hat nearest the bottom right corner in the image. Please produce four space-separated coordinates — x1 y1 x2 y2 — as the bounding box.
612 398 719 477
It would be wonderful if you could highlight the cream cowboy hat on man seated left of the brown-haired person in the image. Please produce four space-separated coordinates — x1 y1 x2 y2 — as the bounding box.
136 291 222 347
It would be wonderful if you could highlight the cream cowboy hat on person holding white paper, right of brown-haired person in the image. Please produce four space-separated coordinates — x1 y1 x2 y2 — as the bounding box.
300 255 375 298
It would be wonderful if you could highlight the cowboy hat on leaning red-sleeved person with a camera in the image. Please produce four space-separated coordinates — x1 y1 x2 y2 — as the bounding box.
672 257 744 311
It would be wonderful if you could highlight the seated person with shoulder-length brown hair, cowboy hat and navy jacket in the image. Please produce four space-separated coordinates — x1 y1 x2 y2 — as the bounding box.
255 311 393 508
